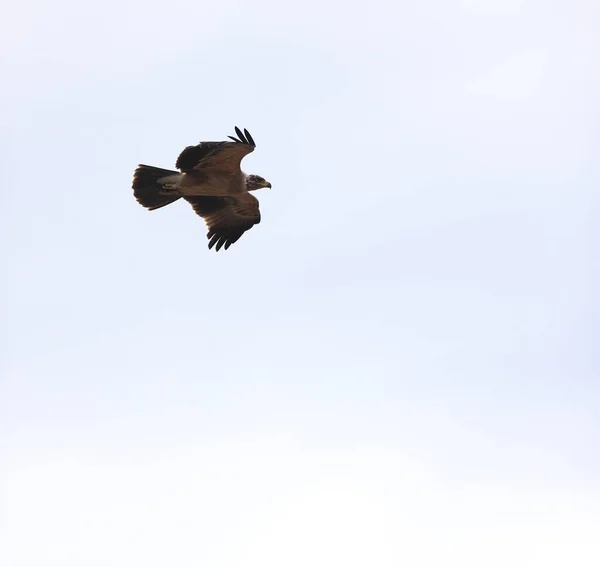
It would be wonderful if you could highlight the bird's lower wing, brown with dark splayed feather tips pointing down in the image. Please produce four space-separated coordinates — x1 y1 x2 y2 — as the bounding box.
184 193 260 252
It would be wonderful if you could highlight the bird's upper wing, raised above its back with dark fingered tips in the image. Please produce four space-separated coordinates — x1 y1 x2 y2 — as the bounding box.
175 126 256 173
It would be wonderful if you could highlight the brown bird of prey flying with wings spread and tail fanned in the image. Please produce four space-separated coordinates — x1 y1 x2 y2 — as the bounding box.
133 130 271 251
